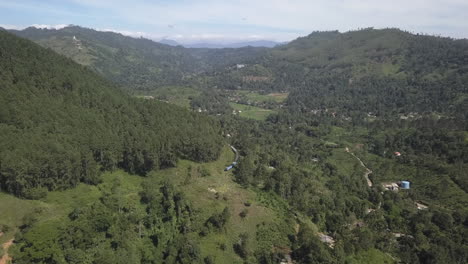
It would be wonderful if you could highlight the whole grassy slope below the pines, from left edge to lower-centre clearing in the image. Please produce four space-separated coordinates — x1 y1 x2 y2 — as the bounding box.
0 146 295 263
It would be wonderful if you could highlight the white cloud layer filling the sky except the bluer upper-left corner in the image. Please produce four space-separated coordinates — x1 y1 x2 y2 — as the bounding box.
63 0 468 39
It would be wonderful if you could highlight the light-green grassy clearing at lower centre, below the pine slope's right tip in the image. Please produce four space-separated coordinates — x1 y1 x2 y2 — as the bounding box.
150 146 294 263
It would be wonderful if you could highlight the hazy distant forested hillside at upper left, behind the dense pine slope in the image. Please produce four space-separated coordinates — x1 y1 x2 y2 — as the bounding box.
12 26 266 91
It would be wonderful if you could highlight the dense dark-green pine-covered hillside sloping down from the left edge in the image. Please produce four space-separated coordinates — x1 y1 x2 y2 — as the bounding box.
0 31 221 198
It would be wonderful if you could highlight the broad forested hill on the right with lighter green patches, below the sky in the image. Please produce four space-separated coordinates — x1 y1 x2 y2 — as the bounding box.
213 29 468 118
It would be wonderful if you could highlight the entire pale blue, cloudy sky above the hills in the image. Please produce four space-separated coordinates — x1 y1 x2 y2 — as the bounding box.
0 0 468 43
